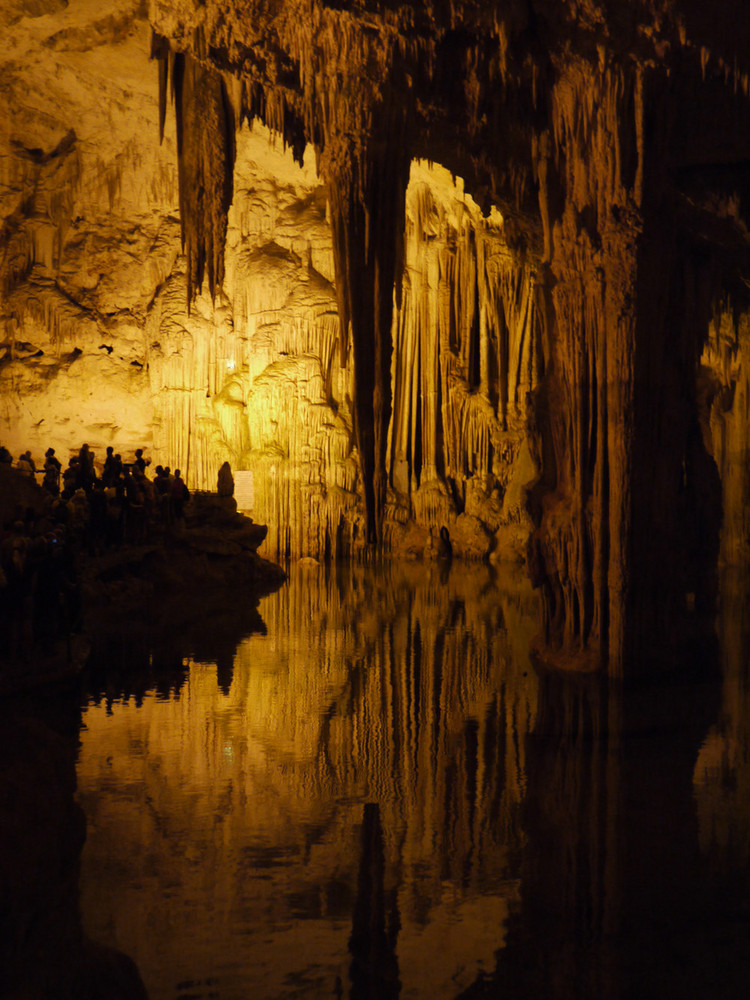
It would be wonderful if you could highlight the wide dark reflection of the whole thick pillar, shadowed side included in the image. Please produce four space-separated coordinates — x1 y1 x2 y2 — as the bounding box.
488 674 734 1000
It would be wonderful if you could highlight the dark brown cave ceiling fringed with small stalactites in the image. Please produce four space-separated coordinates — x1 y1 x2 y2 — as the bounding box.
150 0 750 222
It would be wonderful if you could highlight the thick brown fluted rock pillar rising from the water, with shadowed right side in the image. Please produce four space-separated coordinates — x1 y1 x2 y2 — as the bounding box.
531 57 724 677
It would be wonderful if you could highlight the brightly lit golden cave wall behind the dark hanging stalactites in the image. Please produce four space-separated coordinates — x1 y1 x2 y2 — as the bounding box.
0 3 540 558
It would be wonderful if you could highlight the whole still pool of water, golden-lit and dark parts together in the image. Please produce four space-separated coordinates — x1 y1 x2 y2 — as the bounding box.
78 565 750 1000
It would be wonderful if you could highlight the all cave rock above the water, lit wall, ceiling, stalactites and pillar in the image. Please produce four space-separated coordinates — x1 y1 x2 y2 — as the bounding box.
0 0 750 676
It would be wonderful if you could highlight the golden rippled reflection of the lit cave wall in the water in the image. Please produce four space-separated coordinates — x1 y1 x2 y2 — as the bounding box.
78 566 537 1000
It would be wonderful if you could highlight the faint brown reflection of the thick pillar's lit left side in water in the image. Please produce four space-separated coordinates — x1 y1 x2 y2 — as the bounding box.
488 673 626 1000
